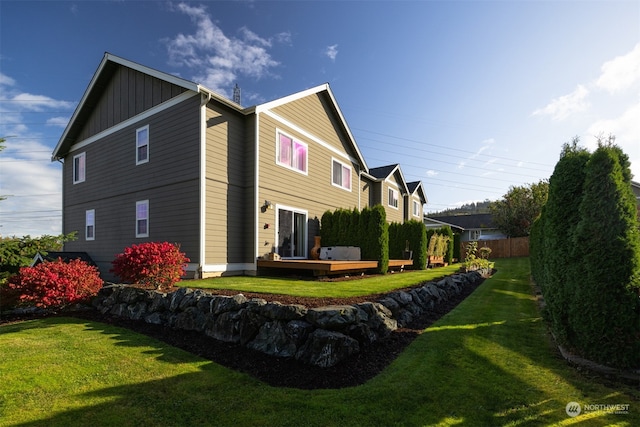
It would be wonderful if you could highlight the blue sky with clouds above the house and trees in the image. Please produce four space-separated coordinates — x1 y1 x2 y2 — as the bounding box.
0 0 640 236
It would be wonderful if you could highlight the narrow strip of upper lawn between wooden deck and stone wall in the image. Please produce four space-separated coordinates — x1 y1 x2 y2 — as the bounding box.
177 264 460 298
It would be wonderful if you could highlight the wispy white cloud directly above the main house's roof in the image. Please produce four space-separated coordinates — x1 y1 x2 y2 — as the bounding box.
167 3 282 96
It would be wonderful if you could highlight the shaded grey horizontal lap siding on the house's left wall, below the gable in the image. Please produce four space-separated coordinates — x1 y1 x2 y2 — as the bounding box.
63 96 200 277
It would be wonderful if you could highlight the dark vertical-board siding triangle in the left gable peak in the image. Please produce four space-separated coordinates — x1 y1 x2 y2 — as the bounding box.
78 65 187 141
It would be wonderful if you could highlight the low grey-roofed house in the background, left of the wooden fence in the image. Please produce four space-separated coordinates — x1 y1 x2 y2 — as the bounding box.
424 214 507 242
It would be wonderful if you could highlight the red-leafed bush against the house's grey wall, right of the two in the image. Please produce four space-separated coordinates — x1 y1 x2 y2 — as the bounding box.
110 242 189 289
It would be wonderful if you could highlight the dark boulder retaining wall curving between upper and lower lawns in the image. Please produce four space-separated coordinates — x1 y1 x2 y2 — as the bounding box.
93 272 482 367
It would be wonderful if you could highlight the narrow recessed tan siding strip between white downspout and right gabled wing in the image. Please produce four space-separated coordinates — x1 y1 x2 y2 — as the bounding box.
205 103 254 266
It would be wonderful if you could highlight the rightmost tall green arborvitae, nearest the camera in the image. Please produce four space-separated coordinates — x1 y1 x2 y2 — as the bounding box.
568 144 640 367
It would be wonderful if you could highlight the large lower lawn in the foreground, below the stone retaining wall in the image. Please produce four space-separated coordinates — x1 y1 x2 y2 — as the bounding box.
0 258 640 427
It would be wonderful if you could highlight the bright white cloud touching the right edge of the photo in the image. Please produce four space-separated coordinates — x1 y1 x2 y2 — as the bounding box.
596 43 640 94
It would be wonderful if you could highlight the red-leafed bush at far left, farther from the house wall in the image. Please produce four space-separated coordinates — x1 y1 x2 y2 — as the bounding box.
8 258 104 308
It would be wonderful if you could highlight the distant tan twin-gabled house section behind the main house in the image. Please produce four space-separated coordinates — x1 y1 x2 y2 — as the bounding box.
362 164 427 222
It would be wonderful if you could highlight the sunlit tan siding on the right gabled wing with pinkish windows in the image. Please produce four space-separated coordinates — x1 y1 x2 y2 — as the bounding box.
257 94 367 256
